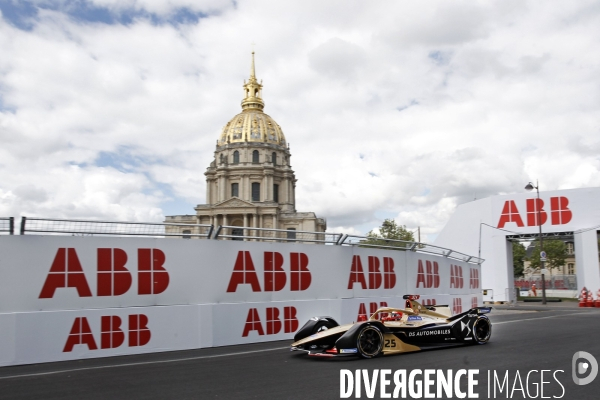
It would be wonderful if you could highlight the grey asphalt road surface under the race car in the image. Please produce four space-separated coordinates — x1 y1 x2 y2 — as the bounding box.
0 305 600 400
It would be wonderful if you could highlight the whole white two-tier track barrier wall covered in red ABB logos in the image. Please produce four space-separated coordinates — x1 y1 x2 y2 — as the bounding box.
0 235 482 365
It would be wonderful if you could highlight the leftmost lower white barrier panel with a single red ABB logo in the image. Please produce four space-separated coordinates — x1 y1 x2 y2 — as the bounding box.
0 306 202 365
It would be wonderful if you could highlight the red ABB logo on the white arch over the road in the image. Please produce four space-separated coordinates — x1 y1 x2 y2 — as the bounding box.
498 196 573 228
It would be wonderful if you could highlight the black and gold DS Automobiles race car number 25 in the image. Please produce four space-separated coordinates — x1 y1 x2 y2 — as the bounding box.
291 295 492 358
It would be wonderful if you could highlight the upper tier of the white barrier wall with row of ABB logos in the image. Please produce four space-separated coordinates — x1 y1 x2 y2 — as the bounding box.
0 236 480 312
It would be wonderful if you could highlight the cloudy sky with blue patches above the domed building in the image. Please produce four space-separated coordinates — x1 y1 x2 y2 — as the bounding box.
0 0 600 241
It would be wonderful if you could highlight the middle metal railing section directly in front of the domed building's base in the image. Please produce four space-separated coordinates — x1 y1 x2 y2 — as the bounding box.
213 225 343 244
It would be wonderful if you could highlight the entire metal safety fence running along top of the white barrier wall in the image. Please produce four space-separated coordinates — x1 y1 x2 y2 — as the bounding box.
6 217 484 264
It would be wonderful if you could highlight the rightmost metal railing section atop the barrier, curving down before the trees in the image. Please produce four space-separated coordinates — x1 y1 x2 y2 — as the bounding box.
337 235 484 264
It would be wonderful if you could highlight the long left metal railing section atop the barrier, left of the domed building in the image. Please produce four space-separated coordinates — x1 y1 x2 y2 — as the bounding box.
20 217 213 239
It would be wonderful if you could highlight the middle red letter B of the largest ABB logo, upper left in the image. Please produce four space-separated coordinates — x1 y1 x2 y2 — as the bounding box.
97 249 131 296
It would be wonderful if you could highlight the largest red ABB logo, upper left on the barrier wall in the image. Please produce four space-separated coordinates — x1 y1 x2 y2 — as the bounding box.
39 248 169 299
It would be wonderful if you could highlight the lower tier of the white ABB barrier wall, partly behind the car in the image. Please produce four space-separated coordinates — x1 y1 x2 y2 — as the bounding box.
0 295 486 366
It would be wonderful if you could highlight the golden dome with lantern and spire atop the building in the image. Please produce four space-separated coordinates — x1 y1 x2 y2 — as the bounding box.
219 52 285 147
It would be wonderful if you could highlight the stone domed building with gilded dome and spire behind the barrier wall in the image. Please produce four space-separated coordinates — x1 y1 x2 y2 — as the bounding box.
165 52 327 238
